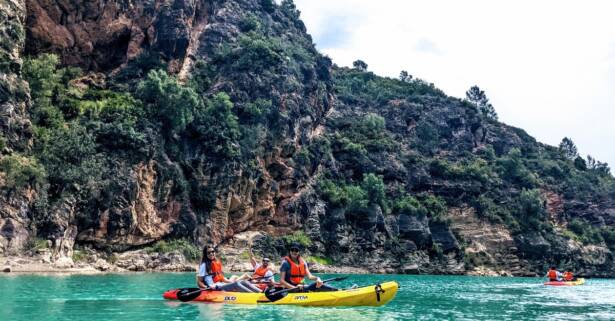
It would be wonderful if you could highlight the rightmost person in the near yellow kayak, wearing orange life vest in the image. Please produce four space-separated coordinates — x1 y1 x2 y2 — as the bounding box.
280 243 337 292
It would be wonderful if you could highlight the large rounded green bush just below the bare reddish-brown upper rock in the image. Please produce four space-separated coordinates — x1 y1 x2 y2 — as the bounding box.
137 70 203 132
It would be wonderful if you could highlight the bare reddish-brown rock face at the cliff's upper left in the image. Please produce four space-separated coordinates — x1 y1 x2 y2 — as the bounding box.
26 0 210 71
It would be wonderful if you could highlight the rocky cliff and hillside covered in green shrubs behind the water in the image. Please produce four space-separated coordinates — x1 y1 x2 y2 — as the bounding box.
0 0 615 276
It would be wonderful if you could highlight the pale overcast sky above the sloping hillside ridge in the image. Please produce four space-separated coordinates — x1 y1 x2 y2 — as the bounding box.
295 0 615 168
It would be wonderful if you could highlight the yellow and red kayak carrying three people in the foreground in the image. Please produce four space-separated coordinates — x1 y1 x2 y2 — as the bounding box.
163 282 399 307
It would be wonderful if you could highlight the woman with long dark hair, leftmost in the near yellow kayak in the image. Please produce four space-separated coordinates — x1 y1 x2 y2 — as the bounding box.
197 245 261 292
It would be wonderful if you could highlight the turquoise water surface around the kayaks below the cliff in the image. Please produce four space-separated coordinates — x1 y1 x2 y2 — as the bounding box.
0 273 615 321
